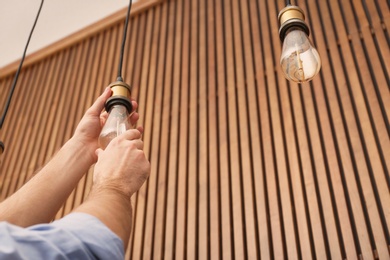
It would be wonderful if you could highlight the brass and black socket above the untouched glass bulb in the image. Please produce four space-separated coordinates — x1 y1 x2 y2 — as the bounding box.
278 5 310 42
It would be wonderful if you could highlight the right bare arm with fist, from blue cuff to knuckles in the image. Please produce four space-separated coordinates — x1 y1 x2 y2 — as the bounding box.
75 129 150 247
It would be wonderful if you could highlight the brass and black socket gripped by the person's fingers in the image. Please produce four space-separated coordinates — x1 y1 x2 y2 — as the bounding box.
105 81 133 113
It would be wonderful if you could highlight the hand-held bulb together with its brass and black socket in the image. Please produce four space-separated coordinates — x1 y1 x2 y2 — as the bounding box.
99 81 132 149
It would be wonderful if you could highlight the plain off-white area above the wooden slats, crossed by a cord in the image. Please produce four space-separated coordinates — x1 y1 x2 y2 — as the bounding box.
0 0 137 68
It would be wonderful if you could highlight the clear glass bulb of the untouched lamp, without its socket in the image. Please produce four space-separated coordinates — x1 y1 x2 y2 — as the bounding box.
280 27 321 83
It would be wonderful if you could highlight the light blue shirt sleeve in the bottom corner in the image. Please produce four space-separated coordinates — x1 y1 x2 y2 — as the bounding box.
0 213 124 260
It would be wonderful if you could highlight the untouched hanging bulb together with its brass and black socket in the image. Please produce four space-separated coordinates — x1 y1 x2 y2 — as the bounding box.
278 5 321 83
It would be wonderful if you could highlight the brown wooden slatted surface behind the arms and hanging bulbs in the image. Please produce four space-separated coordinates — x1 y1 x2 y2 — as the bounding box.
0 0 390 259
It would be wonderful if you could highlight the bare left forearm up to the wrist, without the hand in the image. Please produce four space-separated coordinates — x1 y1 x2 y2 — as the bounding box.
0 139 94 227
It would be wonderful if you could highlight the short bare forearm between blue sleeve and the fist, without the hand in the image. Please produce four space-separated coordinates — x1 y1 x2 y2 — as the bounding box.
75 188 132 250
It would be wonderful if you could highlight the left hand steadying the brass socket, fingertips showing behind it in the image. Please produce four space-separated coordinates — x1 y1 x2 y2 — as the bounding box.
72 87 139 162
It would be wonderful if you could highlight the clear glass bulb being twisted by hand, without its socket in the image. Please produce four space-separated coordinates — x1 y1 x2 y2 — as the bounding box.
99 105 131 149
